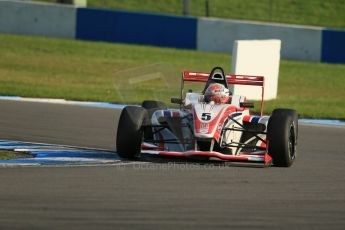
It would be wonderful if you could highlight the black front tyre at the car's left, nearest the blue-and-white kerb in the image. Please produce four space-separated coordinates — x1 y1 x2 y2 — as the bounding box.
116 106 148 158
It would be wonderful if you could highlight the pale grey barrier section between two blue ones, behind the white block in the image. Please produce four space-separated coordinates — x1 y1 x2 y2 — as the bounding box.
197 18 322 62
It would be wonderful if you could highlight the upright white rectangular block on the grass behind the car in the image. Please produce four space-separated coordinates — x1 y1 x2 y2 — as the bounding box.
230 40 281 100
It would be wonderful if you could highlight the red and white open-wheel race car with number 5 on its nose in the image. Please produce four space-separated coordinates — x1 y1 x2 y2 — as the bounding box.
116 67 298 167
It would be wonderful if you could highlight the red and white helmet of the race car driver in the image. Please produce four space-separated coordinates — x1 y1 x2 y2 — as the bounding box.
204 83 229 104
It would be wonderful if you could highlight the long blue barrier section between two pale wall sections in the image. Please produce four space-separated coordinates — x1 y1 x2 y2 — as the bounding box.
76 8 197 49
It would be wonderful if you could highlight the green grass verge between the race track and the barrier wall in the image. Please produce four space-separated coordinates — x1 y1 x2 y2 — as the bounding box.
0 34 345 119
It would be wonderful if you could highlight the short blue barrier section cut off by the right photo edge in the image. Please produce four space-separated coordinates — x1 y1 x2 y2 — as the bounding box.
321 29 345 63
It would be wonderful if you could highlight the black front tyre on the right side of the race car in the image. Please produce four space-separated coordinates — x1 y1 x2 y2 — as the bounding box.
267 109 298 167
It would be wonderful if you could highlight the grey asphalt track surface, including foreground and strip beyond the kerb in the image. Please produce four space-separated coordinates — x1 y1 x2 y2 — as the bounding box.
0 101 345 229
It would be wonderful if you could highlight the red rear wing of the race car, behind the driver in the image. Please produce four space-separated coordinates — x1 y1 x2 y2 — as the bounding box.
181 71 265 116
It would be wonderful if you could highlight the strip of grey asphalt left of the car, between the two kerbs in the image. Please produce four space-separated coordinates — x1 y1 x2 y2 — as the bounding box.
0 100 120 150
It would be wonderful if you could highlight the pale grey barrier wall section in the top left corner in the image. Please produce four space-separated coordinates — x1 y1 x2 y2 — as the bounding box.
0 1 76 38
